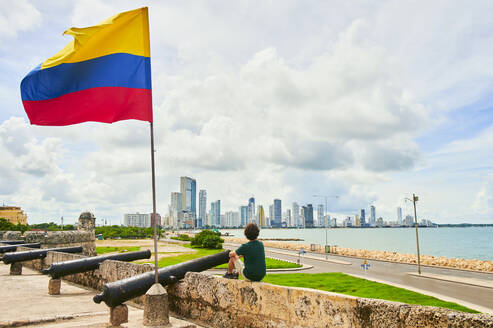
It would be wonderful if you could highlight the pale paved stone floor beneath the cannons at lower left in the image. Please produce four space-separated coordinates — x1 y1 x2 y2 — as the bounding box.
0 264 198 328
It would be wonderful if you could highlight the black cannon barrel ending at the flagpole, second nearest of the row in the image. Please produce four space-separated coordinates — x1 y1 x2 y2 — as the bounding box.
42 250 151 279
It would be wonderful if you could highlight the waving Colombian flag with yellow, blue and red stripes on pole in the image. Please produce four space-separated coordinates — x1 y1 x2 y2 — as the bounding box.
21 8 152 126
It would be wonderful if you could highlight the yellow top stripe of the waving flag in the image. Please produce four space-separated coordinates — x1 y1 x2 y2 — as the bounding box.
41 7 150 69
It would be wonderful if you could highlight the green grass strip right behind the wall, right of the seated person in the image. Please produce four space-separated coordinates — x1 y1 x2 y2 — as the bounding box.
262 272 478 313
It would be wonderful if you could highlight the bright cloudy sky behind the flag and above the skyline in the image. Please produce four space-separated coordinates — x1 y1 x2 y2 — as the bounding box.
0 0 493 224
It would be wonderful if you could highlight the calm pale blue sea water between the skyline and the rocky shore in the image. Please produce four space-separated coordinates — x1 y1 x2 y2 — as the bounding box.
222 227 493 261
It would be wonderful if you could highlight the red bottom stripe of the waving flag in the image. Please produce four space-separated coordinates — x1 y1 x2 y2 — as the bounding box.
22 87 152 126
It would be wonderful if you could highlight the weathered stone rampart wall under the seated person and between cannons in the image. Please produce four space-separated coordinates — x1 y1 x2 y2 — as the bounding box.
10 249 493 328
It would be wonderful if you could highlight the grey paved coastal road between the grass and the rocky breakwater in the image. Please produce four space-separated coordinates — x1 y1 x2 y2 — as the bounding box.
225 244 493 314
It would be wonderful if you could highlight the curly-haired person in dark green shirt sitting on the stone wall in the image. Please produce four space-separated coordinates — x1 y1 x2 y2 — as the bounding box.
223 223 266 281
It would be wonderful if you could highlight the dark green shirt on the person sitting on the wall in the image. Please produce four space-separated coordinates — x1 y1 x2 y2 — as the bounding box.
236 240 266 281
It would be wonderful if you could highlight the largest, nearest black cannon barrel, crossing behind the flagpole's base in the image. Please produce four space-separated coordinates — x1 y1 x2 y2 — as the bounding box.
93 250 230 307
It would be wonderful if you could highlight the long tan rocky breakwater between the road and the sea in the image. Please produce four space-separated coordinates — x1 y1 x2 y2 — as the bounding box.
224 237 493 273
